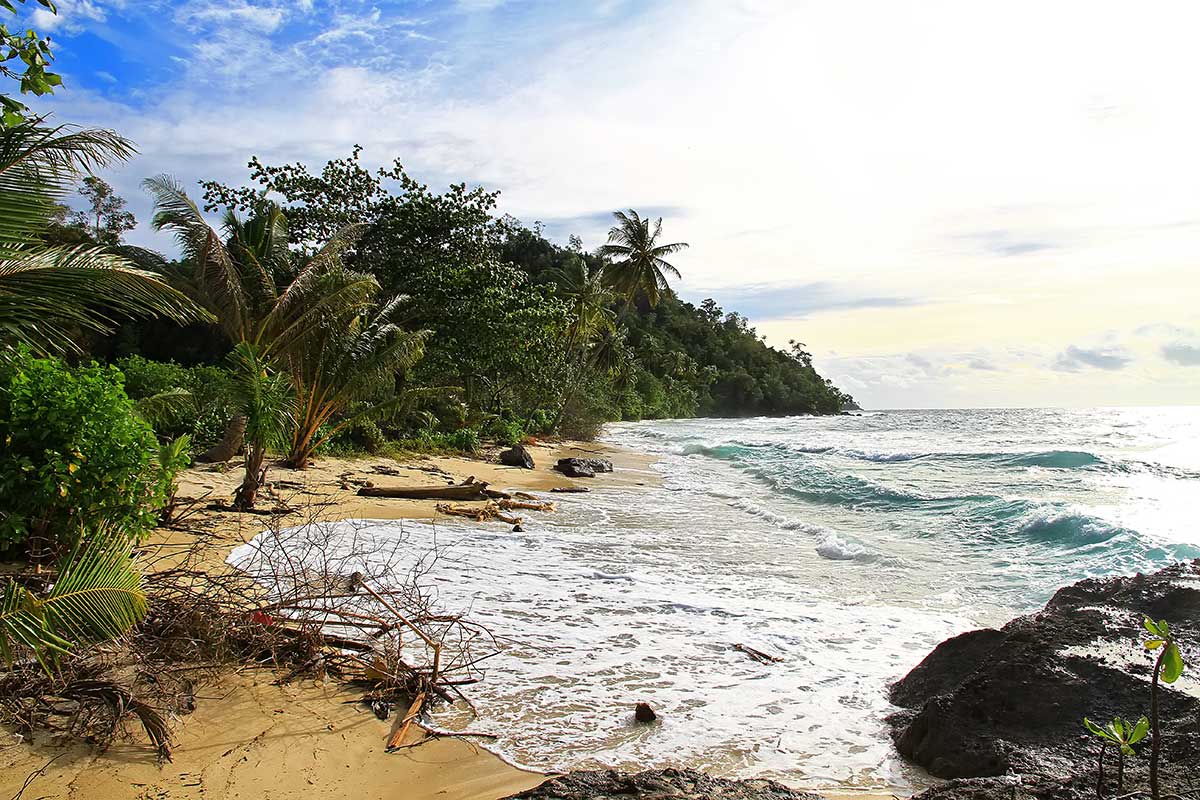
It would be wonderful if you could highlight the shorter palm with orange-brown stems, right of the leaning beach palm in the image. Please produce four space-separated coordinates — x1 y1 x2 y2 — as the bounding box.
288 296 428 469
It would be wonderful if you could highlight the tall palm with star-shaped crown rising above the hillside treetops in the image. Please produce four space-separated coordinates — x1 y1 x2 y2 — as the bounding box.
598 209 688 308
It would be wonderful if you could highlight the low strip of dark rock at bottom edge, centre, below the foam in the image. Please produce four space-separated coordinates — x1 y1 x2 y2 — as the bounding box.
508 769 821 800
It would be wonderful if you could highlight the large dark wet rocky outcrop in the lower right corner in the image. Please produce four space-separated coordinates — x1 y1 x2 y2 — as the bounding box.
889 560 1200 800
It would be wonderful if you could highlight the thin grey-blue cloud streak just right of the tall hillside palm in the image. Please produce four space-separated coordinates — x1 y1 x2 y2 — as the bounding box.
684 282 922 321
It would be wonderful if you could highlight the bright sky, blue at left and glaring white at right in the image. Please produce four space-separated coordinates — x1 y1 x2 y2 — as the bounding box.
16 0 1200 408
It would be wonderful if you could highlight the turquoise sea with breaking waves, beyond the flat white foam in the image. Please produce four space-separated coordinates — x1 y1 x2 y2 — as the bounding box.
611 408 1200 612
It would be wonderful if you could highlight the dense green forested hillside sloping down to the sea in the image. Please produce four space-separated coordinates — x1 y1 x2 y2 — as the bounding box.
46 149 852 455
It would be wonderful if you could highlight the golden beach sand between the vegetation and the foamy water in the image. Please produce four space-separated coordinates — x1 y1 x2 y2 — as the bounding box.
0 443 890 800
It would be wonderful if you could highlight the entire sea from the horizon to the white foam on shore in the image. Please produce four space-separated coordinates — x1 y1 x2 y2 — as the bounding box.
230 408 1200 792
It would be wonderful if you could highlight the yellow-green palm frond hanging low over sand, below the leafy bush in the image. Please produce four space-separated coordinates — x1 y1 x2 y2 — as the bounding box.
0 525 148 672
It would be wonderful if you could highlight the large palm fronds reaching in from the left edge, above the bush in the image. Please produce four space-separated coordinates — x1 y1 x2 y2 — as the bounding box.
0 122 205 354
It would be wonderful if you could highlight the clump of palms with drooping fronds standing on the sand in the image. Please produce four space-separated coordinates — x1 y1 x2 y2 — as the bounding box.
145 175 415 509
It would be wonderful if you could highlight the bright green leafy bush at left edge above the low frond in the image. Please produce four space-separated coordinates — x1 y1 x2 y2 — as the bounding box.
0 350 178 548
